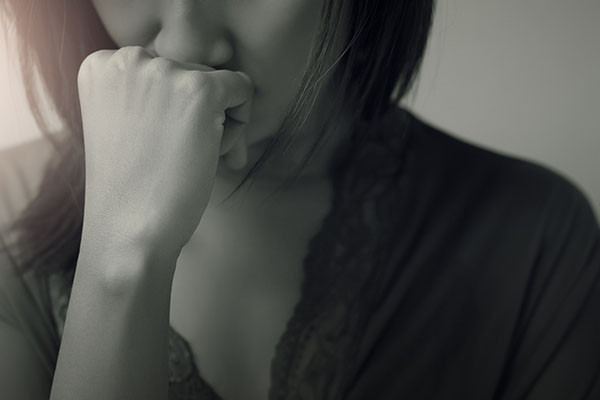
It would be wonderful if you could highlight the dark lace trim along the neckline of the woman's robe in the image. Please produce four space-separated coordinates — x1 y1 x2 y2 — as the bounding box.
49 109 413 400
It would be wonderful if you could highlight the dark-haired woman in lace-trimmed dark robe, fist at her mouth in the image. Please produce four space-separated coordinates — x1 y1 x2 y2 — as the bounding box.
0 0 600 400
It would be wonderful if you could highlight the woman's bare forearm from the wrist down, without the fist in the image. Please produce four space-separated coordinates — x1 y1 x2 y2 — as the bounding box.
50 239 176 400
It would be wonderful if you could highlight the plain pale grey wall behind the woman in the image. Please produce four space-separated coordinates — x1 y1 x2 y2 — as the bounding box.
0 0 600 215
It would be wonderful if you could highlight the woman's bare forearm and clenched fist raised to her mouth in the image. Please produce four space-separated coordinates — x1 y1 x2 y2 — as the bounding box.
50 46 254 400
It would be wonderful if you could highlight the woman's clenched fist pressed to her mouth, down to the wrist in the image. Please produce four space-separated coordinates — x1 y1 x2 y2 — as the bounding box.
77 46 254 254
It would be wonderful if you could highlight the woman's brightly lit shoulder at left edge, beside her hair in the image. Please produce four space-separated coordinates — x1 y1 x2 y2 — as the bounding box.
0 138 55 229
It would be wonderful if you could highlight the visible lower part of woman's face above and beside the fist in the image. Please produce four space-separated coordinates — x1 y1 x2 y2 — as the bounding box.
92 0 324 157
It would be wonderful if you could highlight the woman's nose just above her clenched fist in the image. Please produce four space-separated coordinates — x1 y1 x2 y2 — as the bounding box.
147 0 233 68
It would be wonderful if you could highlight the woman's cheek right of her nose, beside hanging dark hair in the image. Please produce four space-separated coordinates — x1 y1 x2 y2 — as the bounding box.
230 0 322 128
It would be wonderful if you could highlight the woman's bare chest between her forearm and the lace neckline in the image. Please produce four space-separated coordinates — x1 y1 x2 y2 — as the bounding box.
170 179 330 400
